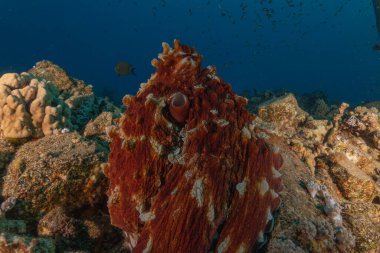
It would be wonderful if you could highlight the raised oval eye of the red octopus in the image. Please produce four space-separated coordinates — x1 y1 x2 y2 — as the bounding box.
169 92 190 124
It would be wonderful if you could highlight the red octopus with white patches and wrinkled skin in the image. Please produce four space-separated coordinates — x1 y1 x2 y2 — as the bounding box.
105 41 282 252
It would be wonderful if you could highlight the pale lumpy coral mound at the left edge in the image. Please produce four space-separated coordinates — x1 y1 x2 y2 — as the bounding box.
0 73 72 139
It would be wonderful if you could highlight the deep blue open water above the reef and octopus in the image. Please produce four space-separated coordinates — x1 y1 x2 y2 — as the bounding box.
0 0 380 104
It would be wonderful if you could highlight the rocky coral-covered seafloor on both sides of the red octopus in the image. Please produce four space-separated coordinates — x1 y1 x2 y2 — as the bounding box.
0 61 380 253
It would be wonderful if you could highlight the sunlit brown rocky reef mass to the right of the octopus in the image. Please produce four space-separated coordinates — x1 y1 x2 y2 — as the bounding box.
245 93 380 252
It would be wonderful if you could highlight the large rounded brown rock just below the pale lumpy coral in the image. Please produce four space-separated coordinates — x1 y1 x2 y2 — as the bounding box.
2 133 107 216
